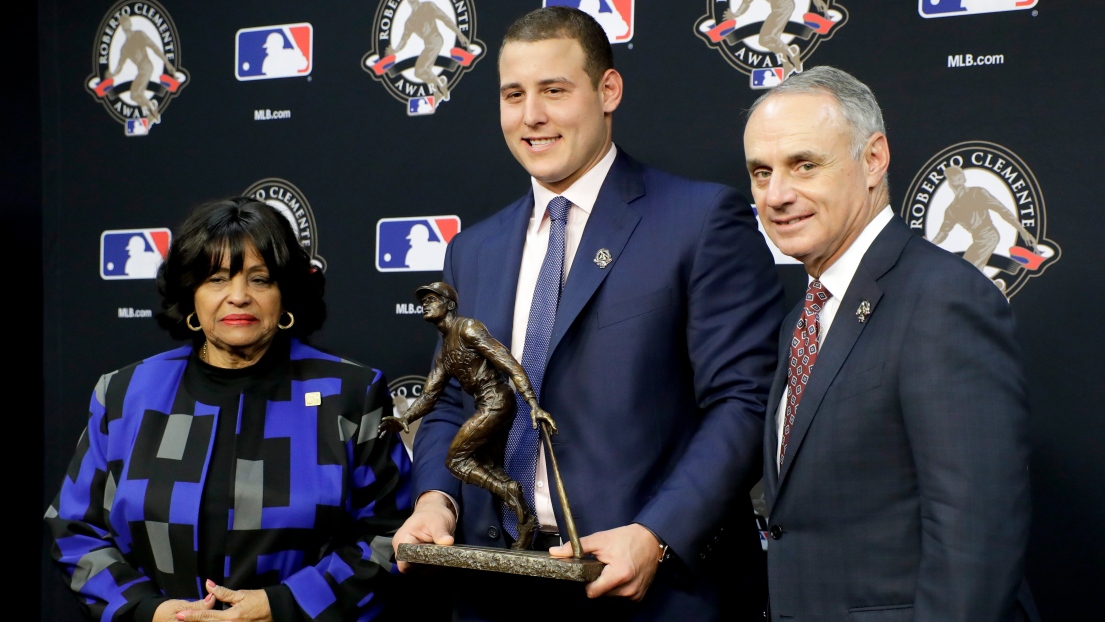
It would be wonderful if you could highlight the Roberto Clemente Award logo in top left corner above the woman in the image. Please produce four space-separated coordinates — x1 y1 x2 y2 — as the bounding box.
85 0 188 136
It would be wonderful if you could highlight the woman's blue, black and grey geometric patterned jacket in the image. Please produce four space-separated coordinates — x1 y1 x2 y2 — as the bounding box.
45 339 410 621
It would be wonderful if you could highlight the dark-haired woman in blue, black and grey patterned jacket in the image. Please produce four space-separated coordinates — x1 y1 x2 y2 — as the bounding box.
45 198 410 622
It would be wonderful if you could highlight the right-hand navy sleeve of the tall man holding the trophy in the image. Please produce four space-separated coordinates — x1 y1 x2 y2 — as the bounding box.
635 188 783 568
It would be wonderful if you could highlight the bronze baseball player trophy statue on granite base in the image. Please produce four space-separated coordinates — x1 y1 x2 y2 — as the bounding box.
379 282 602 581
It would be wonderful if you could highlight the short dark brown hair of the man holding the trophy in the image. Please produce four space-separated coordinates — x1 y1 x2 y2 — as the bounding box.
498 7 614 88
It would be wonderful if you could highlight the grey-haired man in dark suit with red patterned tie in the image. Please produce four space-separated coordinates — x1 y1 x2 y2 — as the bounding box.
745 66 1029 622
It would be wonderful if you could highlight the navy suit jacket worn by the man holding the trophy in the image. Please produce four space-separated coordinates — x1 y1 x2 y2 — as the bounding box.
413 152 783 620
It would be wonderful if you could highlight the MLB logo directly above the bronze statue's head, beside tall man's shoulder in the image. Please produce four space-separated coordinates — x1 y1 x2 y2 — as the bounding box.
376 215 461 272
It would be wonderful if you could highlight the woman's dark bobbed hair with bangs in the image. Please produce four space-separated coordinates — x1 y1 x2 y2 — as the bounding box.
157 197 326 339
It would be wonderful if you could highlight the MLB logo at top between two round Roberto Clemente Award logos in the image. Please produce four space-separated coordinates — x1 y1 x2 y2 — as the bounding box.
234 22 315 81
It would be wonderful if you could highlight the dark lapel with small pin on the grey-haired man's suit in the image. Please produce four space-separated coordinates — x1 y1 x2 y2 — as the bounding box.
776 218 913 497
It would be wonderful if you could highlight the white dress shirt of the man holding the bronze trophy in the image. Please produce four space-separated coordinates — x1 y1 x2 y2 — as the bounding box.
511 145 618 531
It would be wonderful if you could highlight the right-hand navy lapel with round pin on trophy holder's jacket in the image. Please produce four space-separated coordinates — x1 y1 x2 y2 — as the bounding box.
545 151 644 365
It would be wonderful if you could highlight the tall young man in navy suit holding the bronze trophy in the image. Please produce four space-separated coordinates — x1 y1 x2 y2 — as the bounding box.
394 7 782 620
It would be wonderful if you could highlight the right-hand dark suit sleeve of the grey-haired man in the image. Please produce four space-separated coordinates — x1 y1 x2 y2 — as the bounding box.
899 265 1029 622
